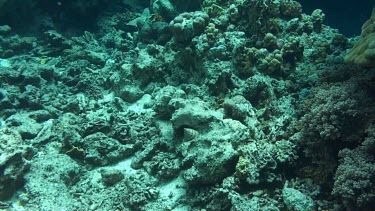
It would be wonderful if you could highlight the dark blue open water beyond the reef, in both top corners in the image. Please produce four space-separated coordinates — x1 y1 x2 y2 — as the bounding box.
0 0 375 37
